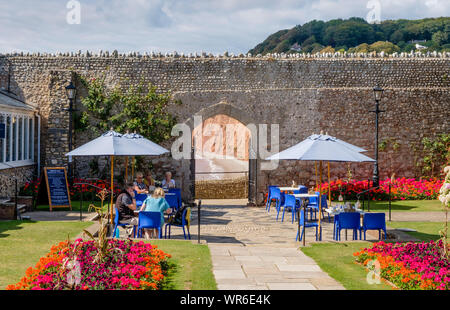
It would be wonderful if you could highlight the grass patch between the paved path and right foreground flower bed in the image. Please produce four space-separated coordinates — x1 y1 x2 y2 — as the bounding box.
301 242 392 290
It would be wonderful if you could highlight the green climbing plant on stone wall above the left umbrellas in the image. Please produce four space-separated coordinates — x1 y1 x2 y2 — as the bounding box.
76 76 180 143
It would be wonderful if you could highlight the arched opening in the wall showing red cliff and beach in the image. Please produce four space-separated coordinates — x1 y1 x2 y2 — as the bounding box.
191 114 251 199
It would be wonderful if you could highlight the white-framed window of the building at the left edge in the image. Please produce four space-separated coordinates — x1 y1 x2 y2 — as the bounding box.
0 109 36 170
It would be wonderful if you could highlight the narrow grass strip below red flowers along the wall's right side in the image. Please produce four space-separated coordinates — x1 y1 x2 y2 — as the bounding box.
344 199 442 212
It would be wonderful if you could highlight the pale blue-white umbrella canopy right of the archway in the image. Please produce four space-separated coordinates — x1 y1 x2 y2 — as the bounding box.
266 135 375 162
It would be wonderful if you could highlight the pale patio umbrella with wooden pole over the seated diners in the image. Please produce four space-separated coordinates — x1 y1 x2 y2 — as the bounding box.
66 130 169 221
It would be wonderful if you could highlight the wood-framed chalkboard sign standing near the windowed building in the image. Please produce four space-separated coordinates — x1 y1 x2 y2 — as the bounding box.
44 167 72 211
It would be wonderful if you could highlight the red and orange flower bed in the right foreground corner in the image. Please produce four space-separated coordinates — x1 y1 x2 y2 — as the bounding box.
353 240 450 290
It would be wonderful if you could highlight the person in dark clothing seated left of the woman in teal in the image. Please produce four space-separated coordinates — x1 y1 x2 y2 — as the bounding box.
116 183 138 238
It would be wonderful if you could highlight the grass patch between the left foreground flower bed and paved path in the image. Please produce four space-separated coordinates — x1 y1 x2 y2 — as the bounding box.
151 240 217 290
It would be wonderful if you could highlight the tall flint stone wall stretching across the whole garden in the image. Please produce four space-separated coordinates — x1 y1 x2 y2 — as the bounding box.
0 52 450 203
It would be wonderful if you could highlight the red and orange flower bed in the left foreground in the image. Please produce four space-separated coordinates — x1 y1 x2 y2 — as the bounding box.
6 239 170 290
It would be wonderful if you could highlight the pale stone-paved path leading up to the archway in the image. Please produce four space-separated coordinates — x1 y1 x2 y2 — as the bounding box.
188 200 344 290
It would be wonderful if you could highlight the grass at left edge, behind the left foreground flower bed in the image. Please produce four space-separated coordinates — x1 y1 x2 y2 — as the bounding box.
0 221 92 289
